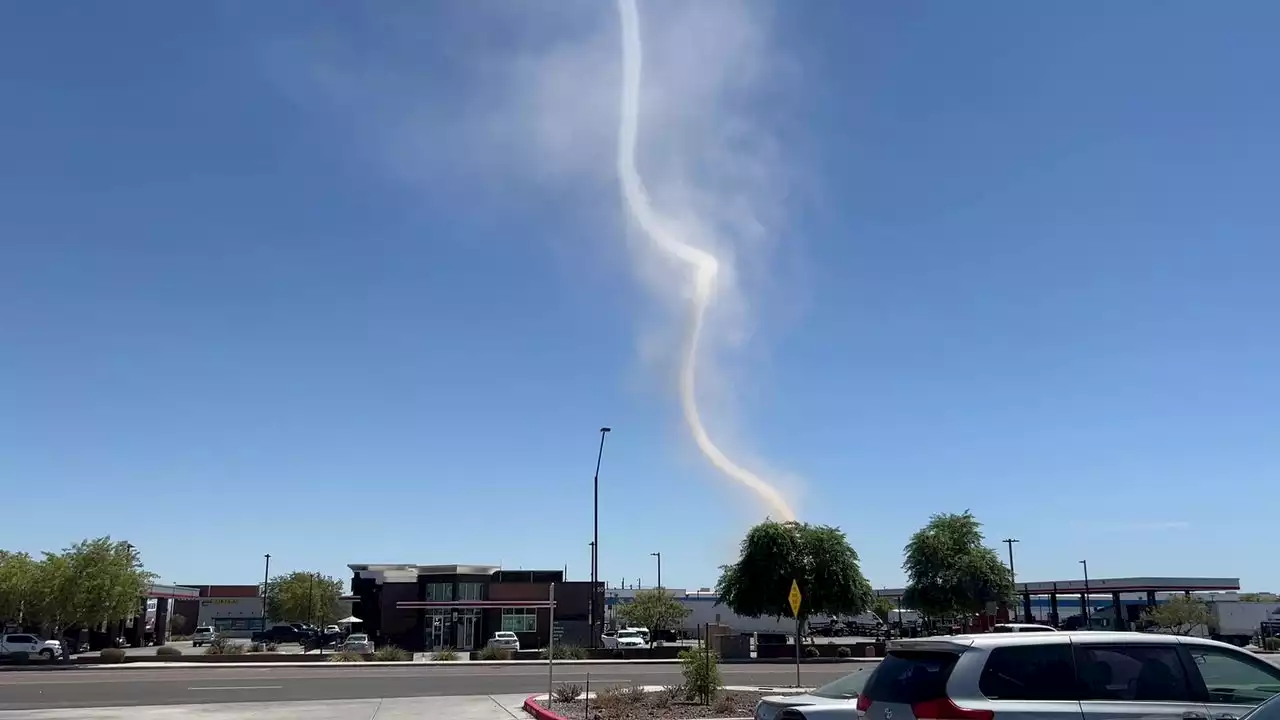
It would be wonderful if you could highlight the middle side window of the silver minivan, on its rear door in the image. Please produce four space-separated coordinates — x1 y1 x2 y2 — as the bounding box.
1075 644 1192 702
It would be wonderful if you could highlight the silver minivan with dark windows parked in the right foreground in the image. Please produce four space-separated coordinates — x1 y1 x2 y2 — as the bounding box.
776 630 1280 720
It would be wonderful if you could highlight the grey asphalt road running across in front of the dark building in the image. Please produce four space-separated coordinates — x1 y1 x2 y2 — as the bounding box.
0 662 858 710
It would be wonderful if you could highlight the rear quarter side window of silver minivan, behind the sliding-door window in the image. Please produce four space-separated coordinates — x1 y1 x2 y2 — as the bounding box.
978 643 1075 700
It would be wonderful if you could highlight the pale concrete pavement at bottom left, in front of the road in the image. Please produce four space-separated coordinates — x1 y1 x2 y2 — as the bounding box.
0 693 529 720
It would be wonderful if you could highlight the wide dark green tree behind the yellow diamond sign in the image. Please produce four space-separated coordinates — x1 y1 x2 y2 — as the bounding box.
716 520 873 623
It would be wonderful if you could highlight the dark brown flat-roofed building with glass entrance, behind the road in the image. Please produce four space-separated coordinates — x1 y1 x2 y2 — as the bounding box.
348 565 604 651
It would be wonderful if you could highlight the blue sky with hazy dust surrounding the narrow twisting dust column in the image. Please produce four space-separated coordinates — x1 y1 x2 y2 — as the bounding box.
0 0 1280 589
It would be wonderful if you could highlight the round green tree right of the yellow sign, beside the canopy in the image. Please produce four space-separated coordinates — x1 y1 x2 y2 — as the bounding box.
902 510 1014 618
